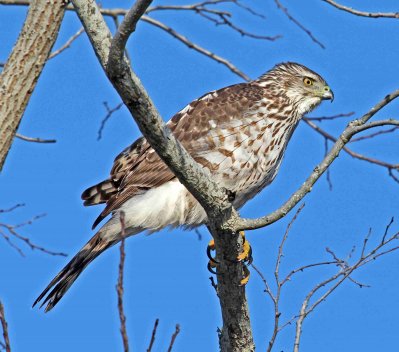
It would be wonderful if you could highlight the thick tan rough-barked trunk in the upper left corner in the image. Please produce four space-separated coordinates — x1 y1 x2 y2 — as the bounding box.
0 0 65 171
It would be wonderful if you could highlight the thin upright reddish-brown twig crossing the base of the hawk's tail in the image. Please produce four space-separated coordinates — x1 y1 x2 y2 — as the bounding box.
116 211 129 352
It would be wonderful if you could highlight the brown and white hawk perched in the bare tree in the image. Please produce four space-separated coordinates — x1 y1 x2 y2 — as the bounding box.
34 62 334 311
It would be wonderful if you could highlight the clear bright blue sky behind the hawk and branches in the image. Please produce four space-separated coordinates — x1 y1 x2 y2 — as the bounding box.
0 0 399 352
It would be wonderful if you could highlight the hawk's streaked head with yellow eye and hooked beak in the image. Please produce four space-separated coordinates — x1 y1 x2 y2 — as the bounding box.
261 62 334 115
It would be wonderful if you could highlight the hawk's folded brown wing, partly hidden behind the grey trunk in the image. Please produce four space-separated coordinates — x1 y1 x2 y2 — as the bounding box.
82 83 264 228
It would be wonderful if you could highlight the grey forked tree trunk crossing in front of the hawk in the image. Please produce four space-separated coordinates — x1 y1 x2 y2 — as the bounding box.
73 0 254 352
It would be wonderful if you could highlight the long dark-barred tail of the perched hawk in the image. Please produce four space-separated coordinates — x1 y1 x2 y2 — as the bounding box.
32 225 140 312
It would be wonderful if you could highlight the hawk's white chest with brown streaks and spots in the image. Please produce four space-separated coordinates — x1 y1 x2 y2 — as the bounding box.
209 118 292 207
